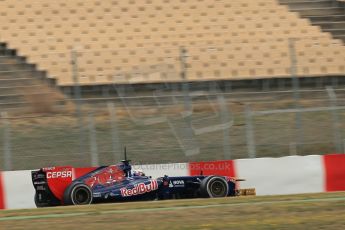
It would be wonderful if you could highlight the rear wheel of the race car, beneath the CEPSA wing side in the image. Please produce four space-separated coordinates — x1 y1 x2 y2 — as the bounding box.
63 182 92 205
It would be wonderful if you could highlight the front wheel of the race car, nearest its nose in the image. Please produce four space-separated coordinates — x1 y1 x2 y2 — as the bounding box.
200 176 229 198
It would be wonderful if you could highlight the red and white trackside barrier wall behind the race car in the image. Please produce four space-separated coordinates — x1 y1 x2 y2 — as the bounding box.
0 154 345 209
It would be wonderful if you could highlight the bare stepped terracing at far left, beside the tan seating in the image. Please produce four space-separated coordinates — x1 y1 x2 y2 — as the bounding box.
0 43 63 111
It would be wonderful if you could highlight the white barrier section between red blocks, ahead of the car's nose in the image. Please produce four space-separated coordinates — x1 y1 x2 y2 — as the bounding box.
235 156 325 195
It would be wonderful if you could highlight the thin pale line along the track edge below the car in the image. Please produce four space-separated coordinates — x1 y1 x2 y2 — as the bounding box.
0 197 345 221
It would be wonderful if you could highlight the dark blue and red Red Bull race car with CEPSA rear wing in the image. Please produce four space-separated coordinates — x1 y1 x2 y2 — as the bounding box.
32 160 255 207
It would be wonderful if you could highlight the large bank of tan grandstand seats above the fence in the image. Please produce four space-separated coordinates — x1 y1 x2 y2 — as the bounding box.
0 0 345 100
